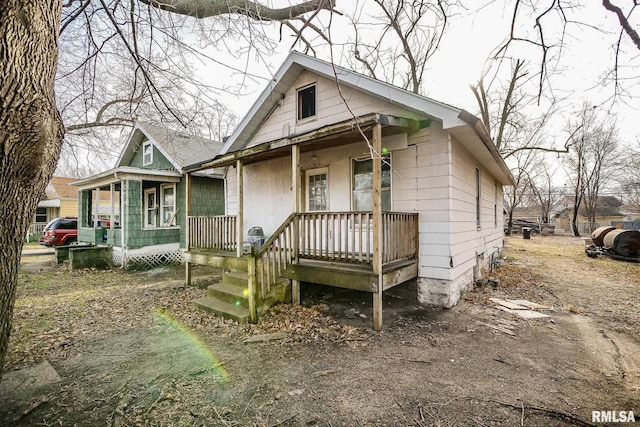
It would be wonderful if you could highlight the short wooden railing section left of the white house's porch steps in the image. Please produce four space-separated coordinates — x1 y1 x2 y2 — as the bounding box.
188 215 238 252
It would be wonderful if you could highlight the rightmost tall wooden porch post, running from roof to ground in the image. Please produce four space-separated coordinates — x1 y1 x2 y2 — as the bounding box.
372 118 384 331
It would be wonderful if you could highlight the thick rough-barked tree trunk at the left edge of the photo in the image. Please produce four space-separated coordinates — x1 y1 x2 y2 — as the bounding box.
0 0 63 378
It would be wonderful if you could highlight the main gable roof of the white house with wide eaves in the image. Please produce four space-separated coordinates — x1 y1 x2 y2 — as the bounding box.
211 51 513 185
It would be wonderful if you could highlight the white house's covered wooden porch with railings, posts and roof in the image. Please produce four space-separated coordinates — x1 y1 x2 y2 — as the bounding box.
184 113 428 330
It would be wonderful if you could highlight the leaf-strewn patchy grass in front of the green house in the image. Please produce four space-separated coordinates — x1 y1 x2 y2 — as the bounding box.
5 255 220 369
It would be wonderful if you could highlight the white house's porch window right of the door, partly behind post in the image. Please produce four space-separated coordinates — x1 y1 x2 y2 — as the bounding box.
351 155 391 212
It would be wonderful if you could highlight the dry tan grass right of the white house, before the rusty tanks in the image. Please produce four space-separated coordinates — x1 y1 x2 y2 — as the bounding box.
500 235 640 337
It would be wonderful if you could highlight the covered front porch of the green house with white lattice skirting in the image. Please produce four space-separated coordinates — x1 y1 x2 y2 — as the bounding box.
74 166 181 268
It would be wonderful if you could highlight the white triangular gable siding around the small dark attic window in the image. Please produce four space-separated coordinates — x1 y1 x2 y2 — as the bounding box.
247 71 415 147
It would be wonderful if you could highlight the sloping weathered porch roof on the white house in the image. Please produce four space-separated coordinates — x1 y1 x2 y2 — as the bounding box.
184 113 422 172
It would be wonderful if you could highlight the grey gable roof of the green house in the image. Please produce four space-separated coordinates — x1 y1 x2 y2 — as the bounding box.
116 121 223 173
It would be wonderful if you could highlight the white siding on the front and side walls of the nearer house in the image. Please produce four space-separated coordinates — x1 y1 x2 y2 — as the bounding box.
227 88 503 307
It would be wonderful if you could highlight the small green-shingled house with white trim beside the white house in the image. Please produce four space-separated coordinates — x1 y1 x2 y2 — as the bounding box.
73 122 225 268
